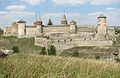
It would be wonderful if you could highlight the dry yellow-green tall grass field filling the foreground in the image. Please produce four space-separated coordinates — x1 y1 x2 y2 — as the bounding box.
0 54 120 78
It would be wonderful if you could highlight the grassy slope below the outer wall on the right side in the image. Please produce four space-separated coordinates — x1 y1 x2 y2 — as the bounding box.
61 36 120 58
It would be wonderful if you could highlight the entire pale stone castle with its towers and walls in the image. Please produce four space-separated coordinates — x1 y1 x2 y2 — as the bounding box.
4 14 115 49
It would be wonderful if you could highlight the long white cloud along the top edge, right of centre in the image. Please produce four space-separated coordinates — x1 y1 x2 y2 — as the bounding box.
52 0 120 6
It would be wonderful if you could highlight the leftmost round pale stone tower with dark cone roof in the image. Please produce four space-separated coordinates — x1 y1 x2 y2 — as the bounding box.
17 20 26 36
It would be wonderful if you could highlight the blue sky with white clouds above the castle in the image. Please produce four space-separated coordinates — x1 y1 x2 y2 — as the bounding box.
0 0 120 27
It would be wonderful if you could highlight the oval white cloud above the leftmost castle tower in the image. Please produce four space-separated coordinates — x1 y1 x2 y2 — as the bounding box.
6 5 26 11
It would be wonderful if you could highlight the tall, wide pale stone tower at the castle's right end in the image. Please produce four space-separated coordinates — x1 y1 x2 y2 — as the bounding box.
97 14 107 34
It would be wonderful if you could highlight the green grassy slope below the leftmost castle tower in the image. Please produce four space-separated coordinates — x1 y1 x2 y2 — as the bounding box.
0 36 41 53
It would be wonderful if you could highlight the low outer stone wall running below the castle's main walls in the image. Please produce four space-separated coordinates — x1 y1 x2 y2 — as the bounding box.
35 38 113 51
